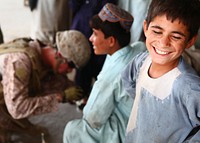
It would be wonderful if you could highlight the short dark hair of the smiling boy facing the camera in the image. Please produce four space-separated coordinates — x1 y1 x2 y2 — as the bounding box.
146 0 200 40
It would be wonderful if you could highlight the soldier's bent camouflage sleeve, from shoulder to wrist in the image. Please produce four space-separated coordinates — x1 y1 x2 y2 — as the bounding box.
2 53 58 119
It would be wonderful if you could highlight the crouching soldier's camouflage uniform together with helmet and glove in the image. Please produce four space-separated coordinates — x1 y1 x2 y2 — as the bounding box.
0 30 91 143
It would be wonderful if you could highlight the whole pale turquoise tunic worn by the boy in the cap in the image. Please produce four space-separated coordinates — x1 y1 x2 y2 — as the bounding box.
63 42 146 143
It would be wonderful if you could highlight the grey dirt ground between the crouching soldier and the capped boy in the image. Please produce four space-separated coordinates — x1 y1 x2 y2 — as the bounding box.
9 103 82 143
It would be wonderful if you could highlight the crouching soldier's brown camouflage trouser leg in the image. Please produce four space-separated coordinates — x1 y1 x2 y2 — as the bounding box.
0 104 48 143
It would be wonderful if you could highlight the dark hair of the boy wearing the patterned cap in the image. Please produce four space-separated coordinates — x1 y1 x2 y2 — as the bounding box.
90 15 131 47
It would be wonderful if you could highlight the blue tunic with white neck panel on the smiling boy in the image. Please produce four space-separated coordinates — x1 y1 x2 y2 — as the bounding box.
122 53 200 143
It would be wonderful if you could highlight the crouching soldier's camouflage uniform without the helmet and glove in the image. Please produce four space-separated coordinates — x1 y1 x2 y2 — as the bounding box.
0 39 73 142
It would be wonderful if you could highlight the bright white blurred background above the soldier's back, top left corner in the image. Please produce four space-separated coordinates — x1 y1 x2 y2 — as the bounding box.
0 0 31 42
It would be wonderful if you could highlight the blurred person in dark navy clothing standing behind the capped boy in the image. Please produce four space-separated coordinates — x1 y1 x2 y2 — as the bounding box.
69 0 117 109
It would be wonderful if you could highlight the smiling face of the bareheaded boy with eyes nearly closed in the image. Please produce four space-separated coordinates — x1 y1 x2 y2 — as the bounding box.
144 15 195 66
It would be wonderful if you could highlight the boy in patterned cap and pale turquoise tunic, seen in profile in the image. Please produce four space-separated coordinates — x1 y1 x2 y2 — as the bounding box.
63 3 146 143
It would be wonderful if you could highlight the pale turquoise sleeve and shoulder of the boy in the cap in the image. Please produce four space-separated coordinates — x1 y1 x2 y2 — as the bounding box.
83 42 146 128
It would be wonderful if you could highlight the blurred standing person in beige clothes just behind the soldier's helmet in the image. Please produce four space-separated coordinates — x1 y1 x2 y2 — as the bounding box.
29 0 72 45
